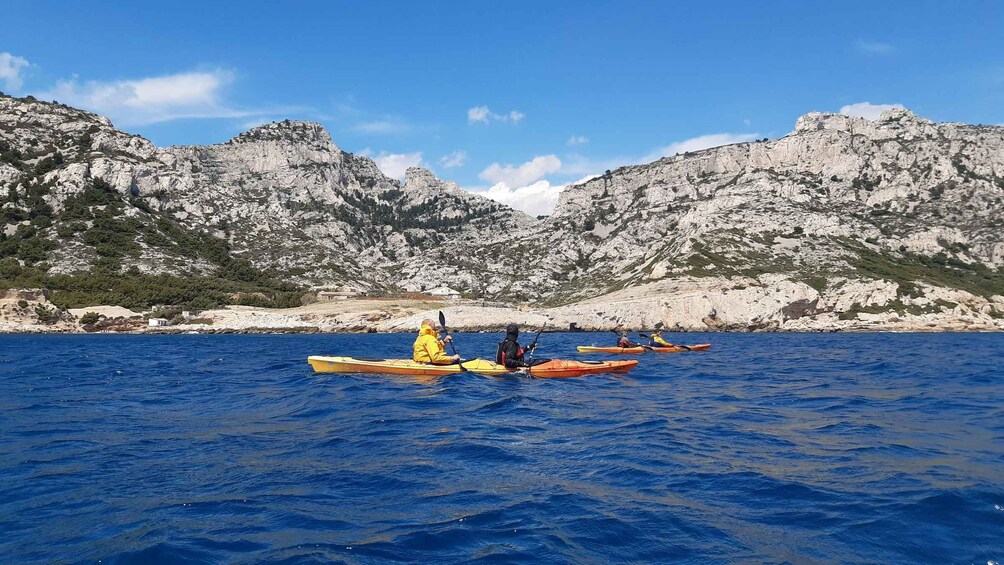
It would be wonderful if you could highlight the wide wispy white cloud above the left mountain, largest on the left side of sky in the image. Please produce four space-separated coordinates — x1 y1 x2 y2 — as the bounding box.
38 69 282 125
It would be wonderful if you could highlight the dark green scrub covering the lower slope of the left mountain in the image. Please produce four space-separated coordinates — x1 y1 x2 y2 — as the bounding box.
0 179 304 310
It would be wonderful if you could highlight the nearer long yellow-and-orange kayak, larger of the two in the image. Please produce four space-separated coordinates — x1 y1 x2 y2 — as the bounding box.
307 355 638 378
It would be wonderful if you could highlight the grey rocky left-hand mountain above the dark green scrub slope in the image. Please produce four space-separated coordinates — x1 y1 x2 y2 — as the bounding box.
0 97 532 288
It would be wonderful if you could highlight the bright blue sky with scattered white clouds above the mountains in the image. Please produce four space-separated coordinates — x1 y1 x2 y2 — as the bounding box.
0 1 1004 211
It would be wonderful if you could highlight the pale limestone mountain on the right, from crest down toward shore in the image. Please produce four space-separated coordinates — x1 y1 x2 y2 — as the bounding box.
397 109 1004 327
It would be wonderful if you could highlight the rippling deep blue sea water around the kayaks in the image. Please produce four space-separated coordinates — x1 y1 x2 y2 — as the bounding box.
0 333 1004 564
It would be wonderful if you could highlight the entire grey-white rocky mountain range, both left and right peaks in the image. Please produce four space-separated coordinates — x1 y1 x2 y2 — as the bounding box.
0 92 1004 329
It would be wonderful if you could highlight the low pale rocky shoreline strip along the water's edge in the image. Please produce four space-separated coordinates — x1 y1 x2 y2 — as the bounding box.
0 275 1004 334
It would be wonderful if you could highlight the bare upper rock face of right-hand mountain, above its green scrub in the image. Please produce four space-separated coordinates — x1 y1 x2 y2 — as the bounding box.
550 109 1004 278
